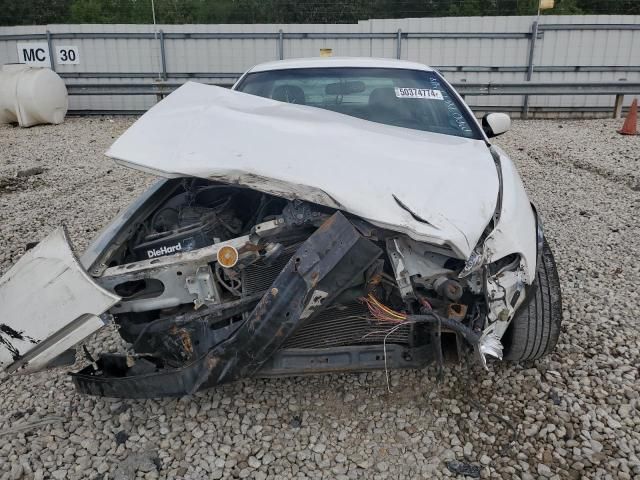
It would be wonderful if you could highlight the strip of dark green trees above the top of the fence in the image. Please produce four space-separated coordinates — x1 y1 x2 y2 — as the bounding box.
0 0 640 25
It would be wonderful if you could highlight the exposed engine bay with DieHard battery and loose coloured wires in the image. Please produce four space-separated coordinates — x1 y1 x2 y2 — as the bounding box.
87 178 502 376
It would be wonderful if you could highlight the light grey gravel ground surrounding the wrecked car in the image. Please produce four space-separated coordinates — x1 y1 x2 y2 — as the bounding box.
0 118 640 479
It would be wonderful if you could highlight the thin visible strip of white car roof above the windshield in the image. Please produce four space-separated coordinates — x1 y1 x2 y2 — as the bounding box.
249 57 433 72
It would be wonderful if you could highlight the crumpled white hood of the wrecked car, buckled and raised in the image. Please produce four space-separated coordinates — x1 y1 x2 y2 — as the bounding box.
107 82 499 258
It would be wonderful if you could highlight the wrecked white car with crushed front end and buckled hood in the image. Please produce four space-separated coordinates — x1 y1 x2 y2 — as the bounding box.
0 58 561 397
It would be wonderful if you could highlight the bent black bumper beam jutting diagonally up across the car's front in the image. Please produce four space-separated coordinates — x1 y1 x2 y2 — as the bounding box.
73 213 382 398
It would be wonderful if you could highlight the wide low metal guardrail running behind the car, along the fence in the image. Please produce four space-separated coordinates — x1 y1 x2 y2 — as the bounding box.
67 80 640 118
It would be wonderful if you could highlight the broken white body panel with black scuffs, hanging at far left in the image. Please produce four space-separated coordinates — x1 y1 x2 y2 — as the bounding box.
0 227 120 372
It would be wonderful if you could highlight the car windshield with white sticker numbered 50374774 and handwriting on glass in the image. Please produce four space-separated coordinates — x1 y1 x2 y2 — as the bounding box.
236 67 482 139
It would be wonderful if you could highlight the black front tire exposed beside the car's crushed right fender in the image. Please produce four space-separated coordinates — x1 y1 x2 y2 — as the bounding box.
503 239 562 362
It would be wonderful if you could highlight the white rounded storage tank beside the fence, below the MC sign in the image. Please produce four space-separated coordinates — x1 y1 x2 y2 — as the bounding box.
0 63 69 127
